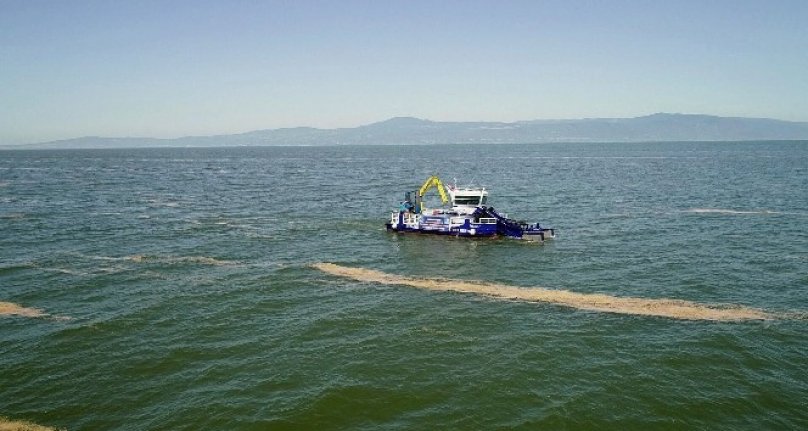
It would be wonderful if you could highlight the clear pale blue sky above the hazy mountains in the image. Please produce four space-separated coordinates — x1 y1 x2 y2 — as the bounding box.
0 0 808 145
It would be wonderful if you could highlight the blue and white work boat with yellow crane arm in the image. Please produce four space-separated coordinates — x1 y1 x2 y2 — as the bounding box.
386 175 555 242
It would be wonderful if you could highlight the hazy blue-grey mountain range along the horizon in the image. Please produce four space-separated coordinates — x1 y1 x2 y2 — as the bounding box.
3 114 808 149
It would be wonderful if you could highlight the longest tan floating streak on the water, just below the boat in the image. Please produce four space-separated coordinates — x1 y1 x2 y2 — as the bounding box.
312 263 774 321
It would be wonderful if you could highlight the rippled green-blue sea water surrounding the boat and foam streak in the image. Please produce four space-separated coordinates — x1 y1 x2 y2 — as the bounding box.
0 142 808 430
